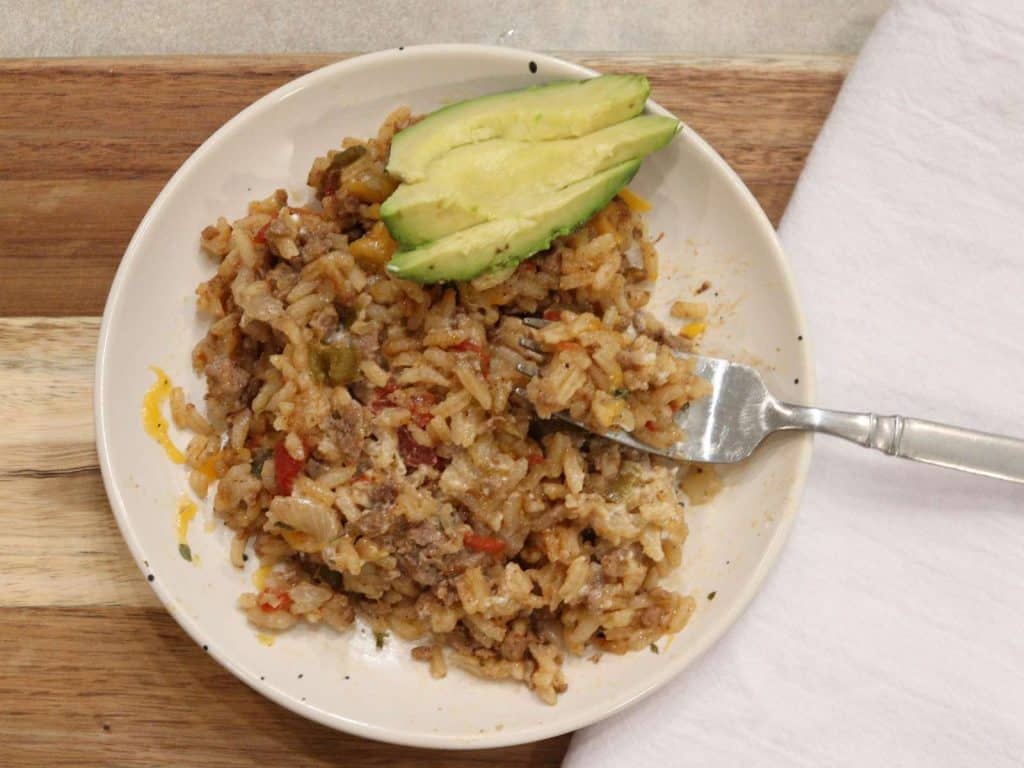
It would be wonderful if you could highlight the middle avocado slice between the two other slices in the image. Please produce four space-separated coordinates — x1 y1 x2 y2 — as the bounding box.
381 115 679 246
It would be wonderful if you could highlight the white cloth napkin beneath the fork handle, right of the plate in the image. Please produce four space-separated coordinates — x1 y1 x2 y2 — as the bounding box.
564 0 1024 768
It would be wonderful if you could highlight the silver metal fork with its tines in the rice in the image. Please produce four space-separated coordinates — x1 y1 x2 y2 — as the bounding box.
516 317 1024 482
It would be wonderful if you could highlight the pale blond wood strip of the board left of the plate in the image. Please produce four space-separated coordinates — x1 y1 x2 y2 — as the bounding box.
0 317 154 610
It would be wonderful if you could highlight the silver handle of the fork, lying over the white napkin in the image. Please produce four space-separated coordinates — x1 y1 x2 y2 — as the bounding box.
776 403 1024 482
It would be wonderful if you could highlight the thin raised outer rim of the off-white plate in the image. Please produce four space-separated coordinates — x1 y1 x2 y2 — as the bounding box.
92 43 816 750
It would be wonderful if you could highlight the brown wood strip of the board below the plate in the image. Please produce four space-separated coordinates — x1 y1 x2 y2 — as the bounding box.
0 608 568 768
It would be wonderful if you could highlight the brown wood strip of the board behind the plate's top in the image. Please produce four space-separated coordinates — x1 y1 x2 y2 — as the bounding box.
0 55 847 315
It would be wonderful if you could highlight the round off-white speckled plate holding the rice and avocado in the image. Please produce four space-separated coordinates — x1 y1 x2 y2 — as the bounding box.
95 45 813 748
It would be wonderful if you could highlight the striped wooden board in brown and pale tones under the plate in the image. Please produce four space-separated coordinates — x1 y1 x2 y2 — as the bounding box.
0 55 848 768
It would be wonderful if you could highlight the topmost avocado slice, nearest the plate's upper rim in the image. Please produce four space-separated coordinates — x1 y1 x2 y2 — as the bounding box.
387 75 650 183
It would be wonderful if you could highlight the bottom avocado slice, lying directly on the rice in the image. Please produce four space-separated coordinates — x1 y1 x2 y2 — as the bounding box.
387 160 640 283
